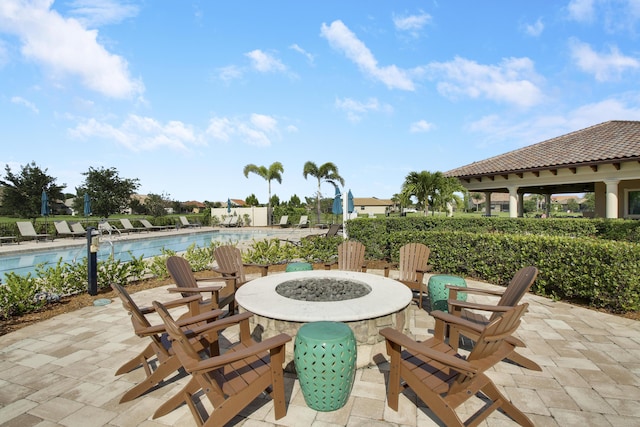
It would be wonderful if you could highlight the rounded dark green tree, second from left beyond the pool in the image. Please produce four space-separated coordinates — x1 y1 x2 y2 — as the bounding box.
76 167 140 218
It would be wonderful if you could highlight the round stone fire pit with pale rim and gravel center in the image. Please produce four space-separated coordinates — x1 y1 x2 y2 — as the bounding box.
236 270 412 370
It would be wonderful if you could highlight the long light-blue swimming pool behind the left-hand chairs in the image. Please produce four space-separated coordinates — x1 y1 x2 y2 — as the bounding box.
0 230 282 281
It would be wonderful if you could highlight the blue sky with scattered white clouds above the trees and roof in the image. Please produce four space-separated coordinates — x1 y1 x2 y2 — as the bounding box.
0 0 640 203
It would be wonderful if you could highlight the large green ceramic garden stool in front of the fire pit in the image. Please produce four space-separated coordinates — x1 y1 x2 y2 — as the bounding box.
293 322 357 412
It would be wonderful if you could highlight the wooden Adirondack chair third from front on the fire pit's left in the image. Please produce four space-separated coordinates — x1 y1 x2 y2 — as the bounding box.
166 255 235 314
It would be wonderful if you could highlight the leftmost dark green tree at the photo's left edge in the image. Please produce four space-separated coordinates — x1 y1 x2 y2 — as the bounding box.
0 162 66 218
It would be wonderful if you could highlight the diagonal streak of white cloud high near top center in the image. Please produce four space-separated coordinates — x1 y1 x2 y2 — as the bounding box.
320 21 415 91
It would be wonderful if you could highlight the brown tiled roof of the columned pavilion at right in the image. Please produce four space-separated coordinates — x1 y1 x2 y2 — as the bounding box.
444 120 640 177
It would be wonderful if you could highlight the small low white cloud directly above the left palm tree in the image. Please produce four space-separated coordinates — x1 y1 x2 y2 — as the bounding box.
206 113 280 147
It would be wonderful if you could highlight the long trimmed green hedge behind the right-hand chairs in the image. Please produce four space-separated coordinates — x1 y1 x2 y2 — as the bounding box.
347 218 640 312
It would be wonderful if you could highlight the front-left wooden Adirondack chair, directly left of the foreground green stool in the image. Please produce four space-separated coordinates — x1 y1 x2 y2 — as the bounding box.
153 302 291 426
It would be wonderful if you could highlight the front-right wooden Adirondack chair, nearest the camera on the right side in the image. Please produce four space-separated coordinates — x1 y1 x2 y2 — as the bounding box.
380 304 533 427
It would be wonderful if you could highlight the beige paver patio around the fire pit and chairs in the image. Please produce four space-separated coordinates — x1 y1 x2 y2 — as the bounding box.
0 270 640 427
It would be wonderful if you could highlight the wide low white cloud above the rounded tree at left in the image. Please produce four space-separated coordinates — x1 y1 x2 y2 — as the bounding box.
69 114 201 151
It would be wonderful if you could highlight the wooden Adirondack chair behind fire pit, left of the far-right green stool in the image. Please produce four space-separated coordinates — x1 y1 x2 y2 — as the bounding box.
384 243 431 309
